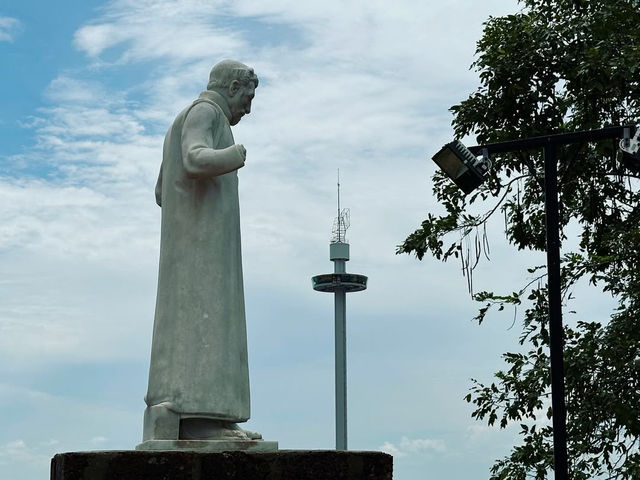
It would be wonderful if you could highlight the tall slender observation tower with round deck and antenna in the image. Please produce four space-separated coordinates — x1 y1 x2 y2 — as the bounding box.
311 178 367 450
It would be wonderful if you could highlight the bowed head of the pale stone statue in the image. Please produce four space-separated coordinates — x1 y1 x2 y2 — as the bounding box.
207 60 258 125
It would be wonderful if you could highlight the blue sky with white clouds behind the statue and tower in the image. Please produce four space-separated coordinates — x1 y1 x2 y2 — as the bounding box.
0 0 620 480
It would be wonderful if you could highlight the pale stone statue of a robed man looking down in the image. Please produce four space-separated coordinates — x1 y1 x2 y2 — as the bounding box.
141 60 259 448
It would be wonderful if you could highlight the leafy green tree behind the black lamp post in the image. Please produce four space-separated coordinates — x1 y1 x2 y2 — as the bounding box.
398 0 640 480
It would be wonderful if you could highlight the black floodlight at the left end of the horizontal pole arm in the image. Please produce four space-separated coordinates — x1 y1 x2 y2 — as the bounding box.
432 140 491 194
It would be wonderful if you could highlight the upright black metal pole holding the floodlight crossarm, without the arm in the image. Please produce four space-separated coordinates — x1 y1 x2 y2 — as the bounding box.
544 142 569 480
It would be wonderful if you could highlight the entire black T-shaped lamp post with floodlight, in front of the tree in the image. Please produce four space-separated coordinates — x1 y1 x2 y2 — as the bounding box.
433 126 640 480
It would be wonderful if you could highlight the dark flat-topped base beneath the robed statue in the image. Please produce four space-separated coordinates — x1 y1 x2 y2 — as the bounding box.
51 450 393 480
